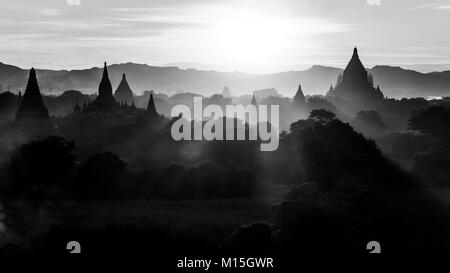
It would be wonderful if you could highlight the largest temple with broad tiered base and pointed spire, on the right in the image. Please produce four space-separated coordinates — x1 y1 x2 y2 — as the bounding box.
327 47 384 107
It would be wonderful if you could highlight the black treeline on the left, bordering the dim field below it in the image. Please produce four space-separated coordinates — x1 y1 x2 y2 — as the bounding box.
2 136 256 202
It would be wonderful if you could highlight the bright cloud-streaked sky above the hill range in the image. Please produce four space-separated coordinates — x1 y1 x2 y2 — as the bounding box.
0 0 450 73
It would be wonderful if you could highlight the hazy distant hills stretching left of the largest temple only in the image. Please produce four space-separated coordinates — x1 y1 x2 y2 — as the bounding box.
0 63 341 96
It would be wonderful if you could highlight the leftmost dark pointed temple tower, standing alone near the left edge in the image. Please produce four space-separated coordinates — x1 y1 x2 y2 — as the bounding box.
16 68 49 121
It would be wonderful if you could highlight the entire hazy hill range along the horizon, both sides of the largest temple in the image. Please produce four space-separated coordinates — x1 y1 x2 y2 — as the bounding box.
0 63 450 98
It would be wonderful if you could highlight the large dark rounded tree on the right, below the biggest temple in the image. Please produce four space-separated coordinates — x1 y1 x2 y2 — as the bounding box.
290 110 404 188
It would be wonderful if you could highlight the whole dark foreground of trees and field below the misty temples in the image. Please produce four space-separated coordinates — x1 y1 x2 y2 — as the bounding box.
1 107 450 257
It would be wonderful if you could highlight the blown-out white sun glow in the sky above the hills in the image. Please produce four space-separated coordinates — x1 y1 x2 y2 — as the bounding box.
200 8 334 73
